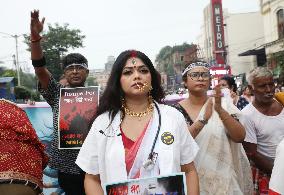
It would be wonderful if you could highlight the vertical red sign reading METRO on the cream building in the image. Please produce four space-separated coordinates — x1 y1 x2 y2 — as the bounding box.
211 0 225 64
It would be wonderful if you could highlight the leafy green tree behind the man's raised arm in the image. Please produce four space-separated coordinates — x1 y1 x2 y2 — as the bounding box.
25 23 85 80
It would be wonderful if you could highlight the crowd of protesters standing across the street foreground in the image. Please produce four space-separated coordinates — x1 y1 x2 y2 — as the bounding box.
0 11 284 195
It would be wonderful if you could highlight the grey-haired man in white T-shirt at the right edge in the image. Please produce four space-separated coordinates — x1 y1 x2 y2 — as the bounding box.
241 67 284 193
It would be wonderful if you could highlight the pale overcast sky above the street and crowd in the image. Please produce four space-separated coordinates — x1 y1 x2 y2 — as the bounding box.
0 0 259 71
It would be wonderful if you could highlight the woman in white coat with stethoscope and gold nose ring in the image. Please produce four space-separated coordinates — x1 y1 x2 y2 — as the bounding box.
76 50 199 195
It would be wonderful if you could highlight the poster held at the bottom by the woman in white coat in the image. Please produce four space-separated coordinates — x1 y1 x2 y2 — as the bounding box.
104 173 187 195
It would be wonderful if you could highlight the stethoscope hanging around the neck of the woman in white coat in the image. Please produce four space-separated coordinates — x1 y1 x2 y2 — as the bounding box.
99 102 162 171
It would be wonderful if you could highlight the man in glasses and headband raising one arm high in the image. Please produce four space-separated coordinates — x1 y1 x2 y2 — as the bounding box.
31 11 89 195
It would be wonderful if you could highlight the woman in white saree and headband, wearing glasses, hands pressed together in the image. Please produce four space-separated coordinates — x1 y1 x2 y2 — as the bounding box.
174 62 253 195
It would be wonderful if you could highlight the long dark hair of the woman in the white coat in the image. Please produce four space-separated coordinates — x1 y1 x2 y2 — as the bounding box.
97 50 164 121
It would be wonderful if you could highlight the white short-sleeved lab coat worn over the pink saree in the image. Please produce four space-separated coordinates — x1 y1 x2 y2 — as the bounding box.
76 104 199 186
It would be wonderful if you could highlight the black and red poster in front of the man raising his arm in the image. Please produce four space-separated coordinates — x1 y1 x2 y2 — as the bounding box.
58 86 99 149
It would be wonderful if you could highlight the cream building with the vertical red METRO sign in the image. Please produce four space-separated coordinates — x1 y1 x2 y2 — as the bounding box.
197 0 264 75
